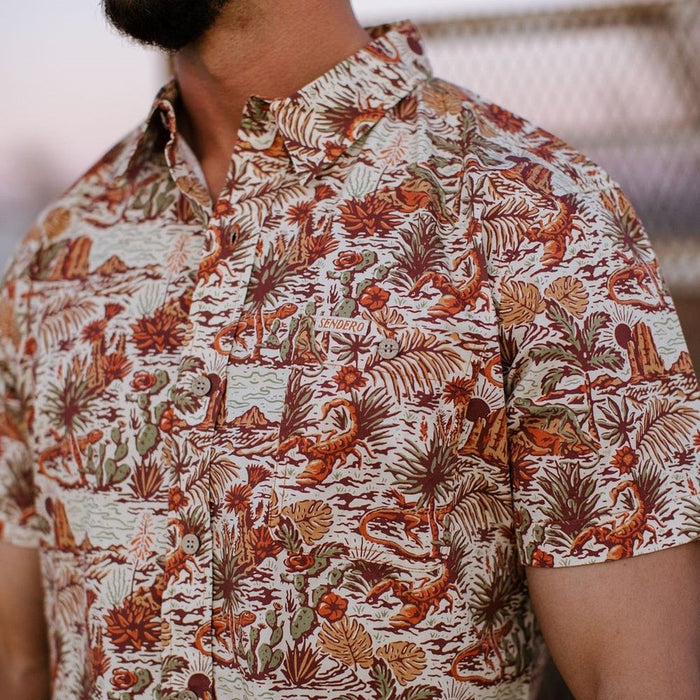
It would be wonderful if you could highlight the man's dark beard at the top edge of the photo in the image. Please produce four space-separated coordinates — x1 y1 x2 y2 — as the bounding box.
102 0 231 51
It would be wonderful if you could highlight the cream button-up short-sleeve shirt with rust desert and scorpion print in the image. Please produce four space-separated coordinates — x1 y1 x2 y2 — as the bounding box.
0 23 700 700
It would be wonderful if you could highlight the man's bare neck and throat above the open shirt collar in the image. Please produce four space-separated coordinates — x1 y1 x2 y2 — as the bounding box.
175 0 369 197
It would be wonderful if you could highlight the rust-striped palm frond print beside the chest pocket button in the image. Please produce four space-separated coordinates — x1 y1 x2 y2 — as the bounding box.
365 328 462 396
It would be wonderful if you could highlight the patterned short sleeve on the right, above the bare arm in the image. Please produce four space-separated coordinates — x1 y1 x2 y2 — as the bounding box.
494 185 700 567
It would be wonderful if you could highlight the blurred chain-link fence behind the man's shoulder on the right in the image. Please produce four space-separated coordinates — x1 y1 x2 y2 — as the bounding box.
420 0 700 367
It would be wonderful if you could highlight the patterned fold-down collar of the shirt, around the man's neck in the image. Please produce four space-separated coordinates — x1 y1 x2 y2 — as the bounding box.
117 21 432 185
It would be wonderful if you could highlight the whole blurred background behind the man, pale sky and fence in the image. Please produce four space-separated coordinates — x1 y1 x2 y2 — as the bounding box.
0 0 700 700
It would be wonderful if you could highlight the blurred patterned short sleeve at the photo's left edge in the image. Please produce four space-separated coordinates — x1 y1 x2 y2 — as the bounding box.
0 232 41 547
